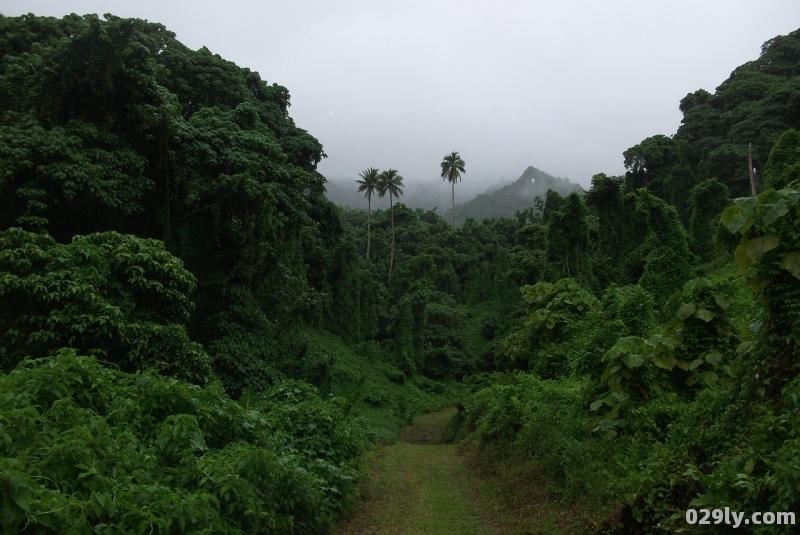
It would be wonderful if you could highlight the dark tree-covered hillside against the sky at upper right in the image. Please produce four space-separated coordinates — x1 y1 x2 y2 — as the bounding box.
624 32 800 223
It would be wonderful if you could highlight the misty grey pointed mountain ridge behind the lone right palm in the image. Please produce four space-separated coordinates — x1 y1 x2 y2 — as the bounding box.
445 166 583 224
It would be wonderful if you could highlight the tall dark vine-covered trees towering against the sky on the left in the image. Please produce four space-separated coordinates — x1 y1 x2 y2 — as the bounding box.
0 15 343 393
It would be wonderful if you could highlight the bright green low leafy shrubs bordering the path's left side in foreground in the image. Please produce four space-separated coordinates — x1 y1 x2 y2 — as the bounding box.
0 350 362 534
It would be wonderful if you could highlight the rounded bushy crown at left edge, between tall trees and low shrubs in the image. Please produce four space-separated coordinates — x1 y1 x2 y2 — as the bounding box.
0 228 211 383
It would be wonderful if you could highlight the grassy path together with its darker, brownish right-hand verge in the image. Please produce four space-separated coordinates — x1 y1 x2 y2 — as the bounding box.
334 407 594 535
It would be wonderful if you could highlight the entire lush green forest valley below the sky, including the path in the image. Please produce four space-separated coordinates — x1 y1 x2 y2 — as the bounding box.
0 15 800 535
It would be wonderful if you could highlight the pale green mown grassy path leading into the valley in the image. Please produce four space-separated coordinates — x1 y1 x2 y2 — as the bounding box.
334 408 498 535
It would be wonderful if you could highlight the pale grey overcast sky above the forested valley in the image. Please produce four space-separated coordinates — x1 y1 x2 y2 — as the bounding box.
0 0 800 192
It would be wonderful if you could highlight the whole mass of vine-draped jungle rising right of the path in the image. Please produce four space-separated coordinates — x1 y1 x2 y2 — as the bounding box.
453 26 800 534
